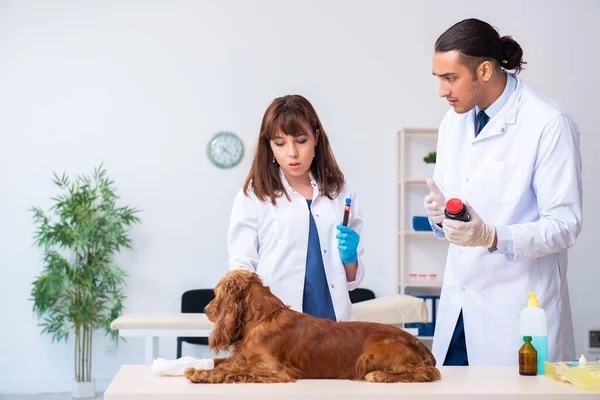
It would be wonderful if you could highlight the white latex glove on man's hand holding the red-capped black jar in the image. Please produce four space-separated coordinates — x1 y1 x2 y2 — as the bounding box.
443 201 496 248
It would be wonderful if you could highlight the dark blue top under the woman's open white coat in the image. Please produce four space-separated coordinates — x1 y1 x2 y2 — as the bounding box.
302 200 336 321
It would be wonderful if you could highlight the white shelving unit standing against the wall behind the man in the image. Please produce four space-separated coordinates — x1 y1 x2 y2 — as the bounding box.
397 128 448 341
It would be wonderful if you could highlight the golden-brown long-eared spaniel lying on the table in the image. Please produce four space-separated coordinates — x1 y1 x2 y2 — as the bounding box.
185 270 441 383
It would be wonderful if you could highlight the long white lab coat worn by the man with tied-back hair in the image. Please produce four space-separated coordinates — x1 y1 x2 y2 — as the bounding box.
433 76 582 365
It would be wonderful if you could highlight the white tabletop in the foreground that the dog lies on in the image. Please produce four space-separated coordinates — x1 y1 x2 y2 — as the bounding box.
104 365 600 400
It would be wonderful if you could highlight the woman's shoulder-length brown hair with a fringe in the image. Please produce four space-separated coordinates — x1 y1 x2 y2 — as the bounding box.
244 95 344 205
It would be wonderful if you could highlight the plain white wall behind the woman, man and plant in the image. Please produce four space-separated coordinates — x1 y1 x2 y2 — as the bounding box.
0 0 600 392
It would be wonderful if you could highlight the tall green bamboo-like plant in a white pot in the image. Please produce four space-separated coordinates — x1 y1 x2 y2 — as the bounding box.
31 166 140 398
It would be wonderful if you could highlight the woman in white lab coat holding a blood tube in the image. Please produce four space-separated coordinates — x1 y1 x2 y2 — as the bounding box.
227 95 364 321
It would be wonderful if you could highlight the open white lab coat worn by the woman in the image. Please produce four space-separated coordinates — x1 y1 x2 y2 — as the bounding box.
227 171 364 321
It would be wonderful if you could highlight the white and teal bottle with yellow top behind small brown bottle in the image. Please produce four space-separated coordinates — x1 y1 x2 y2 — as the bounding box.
517 292 548 375
